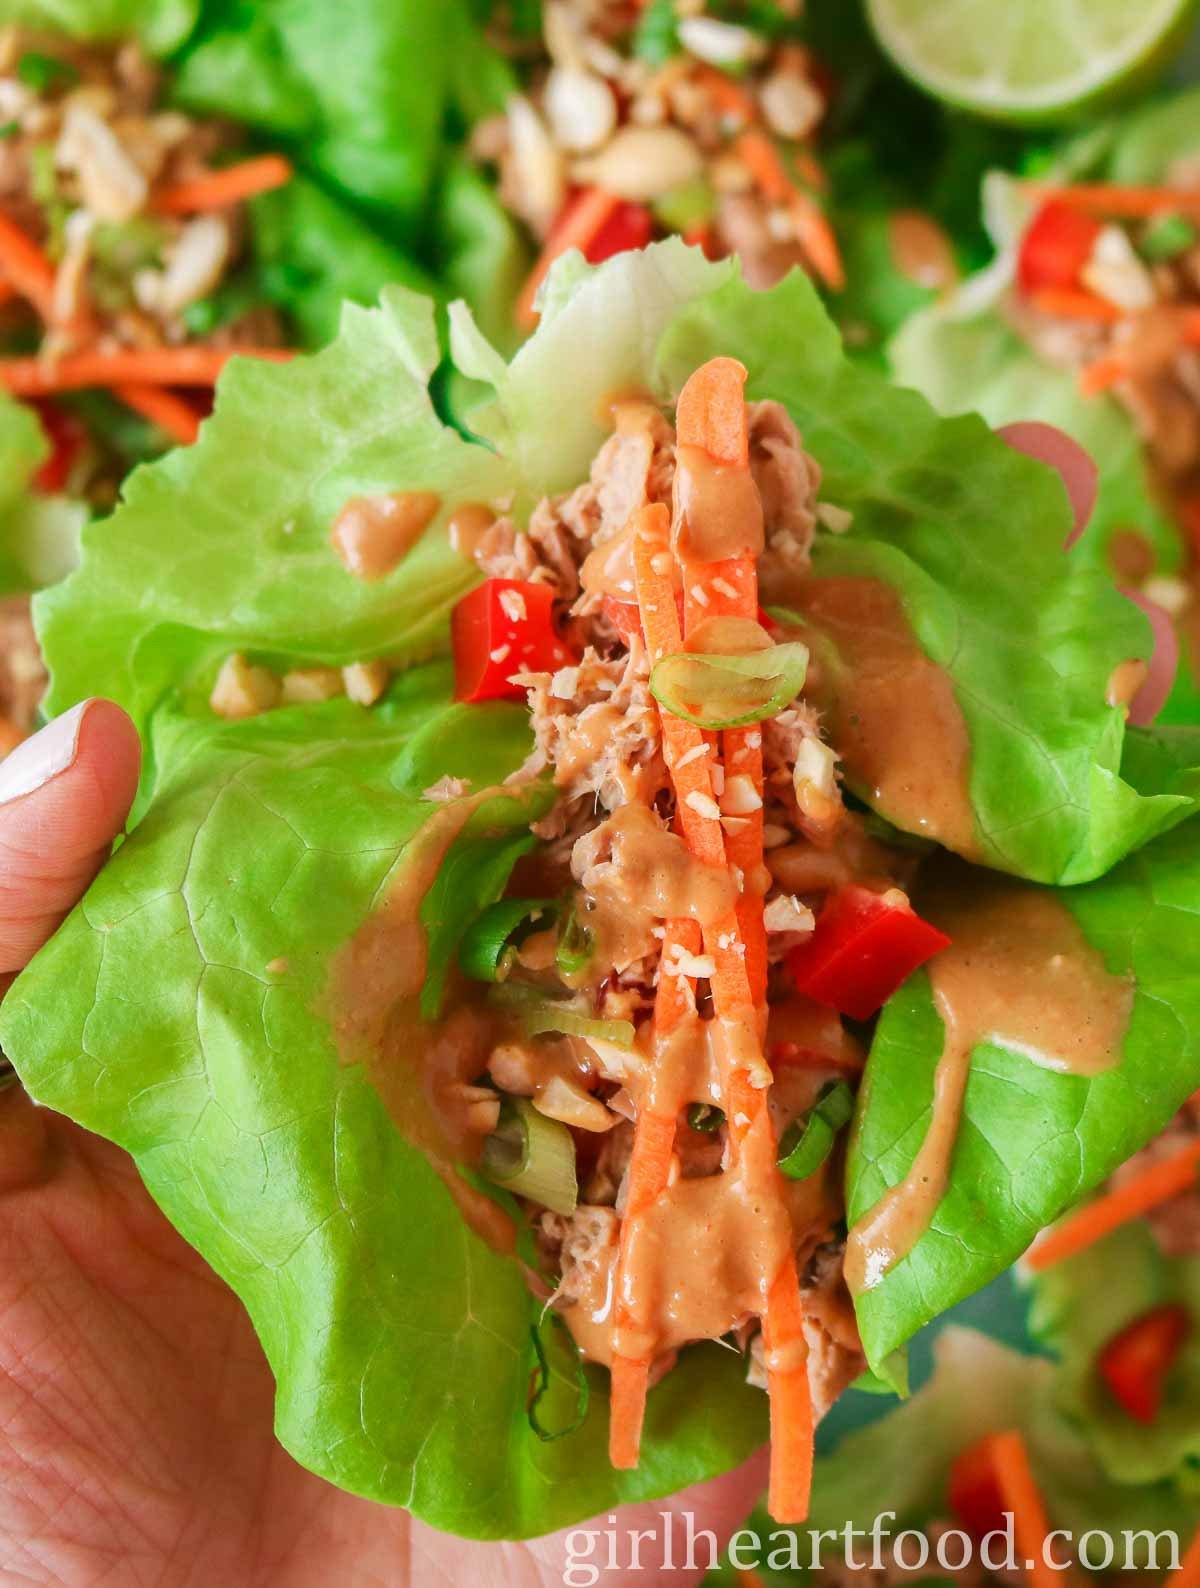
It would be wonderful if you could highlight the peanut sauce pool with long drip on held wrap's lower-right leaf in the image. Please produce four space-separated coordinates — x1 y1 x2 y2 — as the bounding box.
846 867 1133 1296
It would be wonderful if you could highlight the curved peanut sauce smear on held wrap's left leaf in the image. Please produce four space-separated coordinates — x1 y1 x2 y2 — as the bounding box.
330 788 516 1251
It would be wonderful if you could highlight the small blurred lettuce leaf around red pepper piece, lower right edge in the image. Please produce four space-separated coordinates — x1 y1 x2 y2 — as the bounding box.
1029 1220 1200 1493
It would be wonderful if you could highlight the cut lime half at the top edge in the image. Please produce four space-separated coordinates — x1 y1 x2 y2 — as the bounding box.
868 0 1195 122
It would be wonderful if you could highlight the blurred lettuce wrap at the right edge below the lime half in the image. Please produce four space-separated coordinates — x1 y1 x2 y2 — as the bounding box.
889 89 1200 723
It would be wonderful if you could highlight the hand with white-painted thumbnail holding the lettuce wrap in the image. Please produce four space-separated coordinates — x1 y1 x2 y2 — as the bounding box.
0 700 765 1588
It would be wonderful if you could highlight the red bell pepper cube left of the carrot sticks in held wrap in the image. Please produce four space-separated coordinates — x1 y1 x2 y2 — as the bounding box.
451 580 579 700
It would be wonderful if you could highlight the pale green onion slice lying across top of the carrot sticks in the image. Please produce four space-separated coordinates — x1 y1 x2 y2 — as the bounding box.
649 640 808 729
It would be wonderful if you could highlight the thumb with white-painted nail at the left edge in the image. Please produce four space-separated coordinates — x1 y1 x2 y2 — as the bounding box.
0 700 141 973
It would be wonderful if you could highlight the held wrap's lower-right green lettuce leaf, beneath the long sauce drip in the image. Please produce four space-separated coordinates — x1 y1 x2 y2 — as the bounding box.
846 813 1200 1370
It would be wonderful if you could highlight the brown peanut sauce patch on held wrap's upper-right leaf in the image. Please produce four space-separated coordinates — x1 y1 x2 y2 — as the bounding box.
789 576 979 859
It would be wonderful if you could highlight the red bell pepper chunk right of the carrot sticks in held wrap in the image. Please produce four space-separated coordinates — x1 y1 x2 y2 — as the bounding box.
787 886 949 1019
